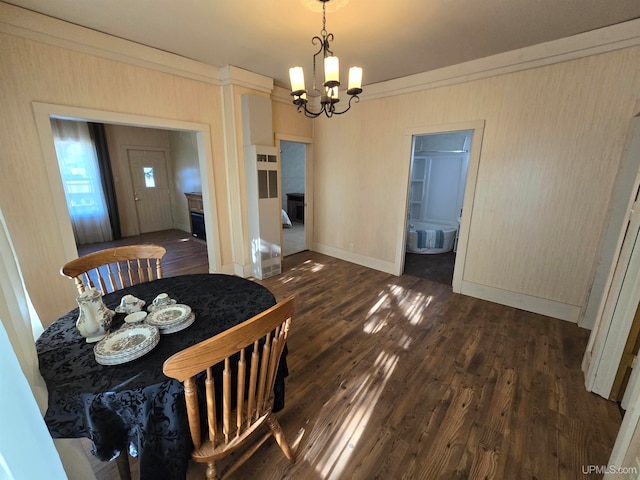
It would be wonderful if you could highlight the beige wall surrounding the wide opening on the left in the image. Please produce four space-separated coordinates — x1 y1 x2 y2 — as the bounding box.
0 34 251 324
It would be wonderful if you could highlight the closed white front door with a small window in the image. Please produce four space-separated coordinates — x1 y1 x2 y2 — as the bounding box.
127 149 173 233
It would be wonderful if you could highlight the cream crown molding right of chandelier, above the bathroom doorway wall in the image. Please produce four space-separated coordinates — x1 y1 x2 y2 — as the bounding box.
360 19 640 101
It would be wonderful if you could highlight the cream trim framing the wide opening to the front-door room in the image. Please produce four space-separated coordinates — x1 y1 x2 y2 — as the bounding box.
32 102 222 273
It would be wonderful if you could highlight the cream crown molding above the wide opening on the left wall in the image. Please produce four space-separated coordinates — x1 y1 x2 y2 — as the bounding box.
0 2 220 85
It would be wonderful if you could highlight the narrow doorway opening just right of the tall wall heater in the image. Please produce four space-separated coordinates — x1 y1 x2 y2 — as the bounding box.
280 140 307 257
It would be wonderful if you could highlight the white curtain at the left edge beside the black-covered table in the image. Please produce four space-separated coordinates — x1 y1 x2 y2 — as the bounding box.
0 211 95 480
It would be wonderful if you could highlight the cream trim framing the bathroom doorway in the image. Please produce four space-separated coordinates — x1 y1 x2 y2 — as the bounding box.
396 120 485 293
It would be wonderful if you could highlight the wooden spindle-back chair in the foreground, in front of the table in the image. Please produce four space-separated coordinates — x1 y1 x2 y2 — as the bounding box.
163 296 295 480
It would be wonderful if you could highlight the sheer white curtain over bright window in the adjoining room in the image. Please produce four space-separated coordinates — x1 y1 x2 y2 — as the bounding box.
51 118 113 245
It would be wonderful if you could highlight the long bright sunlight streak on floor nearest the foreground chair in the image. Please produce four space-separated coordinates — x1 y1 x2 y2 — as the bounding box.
304 352 398 480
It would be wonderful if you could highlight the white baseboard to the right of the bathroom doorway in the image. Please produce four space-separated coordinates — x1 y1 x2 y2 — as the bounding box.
460 280 580 323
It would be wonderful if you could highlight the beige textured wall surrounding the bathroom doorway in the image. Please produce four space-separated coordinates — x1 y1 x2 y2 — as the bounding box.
314 47 640 320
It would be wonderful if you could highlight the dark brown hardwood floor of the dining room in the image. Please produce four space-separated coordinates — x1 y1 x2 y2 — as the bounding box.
82 232 621 480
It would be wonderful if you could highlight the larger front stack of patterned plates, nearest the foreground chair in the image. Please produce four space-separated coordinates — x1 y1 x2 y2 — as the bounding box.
93 324 160 365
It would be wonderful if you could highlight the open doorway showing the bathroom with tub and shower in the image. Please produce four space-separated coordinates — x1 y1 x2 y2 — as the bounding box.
404 130 473 285
